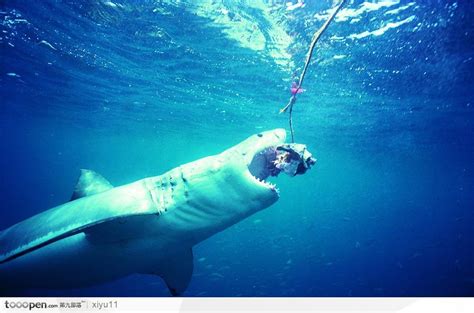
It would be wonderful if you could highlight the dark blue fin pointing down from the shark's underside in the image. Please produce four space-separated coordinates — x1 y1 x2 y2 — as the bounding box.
148 249 194 296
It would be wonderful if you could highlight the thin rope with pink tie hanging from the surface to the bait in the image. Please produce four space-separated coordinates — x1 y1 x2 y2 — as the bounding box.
280 0 345 143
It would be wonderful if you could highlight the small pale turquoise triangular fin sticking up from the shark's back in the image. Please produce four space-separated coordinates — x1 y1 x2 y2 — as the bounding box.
71 169 114 201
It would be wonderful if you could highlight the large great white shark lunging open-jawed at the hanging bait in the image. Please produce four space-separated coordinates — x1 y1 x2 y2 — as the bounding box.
0 129 309 295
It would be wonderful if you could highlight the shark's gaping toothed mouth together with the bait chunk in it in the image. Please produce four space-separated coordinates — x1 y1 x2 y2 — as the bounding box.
248 144 316 193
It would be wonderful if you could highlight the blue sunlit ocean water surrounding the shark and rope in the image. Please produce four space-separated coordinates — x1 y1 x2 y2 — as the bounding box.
0 0 474 296
